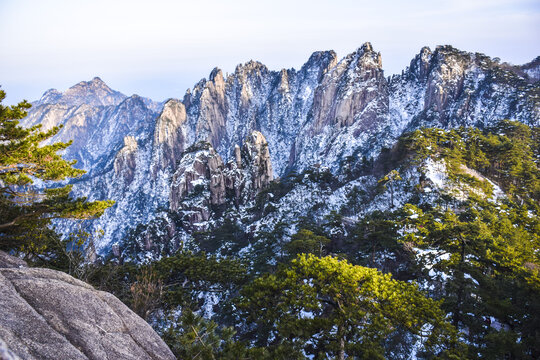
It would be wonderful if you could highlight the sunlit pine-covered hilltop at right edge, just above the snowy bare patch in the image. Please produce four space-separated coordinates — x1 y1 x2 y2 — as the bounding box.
400 120 540 205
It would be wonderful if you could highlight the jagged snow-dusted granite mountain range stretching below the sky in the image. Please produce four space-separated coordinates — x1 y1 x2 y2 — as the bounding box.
25 43 540 253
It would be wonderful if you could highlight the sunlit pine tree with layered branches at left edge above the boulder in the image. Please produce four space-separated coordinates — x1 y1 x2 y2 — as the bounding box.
0 90 114 251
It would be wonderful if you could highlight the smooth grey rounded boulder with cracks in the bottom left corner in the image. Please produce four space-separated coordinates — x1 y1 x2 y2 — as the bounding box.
0 251 175 360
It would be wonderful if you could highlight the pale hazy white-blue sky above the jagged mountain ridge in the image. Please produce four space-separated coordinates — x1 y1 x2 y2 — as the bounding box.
0 0 540 103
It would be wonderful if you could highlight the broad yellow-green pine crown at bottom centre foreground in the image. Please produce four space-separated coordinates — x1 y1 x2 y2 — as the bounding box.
238 254 457 359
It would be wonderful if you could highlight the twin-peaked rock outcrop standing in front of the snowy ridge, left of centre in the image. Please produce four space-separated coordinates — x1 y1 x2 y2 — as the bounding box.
170 131 273 228
